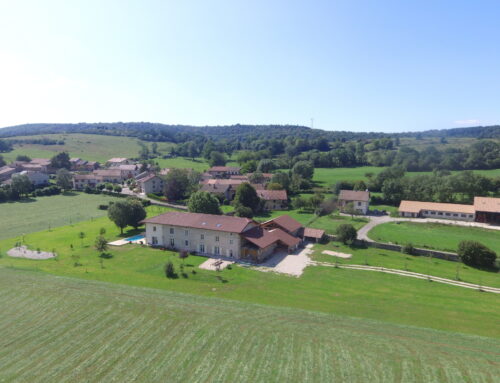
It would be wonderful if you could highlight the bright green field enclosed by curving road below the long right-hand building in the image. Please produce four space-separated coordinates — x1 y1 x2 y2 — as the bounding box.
368 222 500 255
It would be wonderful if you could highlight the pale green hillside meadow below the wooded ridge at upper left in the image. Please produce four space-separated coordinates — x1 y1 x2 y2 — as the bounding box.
3 133 172 163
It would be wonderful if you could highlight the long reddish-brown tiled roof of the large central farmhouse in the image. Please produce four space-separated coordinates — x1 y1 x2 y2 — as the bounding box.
142 211 253 233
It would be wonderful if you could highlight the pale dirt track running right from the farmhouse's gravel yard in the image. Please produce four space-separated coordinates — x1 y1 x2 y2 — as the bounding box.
310 261 500 294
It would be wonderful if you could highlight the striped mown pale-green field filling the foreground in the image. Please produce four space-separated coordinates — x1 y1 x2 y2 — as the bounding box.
0 269 500 383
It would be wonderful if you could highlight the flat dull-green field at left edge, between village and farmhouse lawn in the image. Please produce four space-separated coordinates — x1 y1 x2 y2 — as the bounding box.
0 192 121 239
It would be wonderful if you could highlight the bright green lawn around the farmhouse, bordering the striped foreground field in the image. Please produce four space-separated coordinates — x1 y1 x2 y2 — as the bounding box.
0 213 500 337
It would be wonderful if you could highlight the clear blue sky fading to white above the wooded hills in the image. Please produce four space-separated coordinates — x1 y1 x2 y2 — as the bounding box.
0 0 500 131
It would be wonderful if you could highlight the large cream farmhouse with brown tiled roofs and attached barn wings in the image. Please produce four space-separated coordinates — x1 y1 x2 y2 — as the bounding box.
143 212 312 262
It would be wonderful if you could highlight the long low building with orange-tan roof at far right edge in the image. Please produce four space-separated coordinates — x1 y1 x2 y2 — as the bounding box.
399 197 500 224
